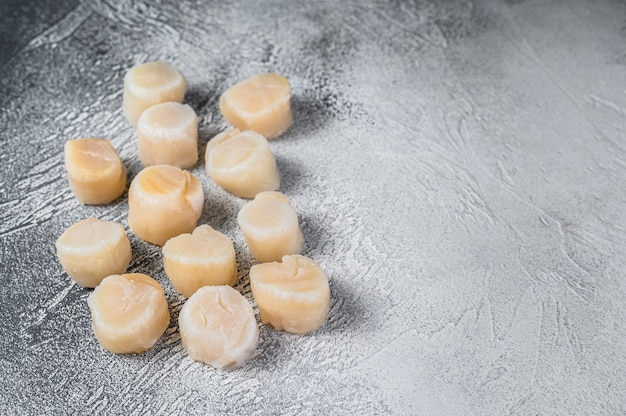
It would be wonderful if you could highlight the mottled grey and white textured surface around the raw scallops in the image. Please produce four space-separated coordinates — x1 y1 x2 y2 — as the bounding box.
0 0 626 415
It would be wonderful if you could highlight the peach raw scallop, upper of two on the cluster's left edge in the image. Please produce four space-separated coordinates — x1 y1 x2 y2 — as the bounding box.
64 138 126 205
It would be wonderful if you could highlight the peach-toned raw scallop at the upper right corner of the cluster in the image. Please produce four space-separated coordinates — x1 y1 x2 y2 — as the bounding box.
220 74 293 139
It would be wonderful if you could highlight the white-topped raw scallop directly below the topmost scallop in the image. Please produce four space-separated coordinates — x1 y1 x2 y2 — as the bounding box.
137 102 198 168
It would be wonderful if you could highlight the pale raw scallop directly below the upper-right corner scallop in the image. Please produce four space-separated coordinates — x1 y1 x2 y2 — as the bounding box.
205 129 280 198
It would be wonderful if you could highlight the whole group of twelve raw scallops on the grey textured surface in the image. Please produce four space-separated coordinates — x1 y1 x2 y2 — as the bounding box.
56 62 330 368
